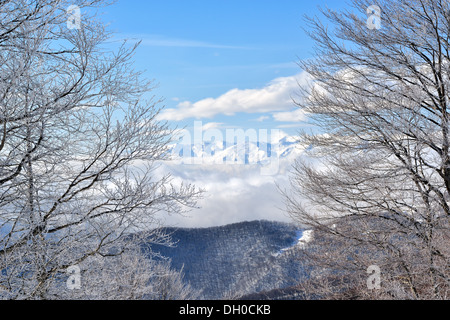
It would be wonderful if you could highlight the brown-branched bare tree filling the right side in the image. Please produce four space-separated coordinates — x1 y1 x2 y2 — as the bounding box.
285 0 450 299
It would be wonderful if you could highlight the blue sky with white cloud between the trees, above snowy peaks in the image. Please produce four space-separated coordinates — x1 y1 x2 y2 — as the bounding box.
103 0 345 134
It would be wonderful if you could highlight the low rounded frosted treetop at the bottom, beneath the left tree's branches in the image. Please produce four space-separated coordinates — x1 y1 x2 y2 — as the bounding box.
55 243 198 300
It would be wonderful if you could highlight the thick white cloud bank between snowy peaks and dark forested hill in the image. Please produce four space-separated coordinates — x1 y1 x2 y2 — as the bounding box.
155 161 291 228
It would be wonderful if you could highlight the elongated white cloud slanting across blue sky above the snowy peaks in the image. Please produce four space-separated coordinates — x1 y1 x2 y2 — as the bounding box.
159 72 309 121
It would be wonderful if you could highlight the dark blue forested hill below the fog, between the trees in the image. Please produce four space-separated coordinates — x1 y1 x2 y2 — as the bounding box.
144 221 307 299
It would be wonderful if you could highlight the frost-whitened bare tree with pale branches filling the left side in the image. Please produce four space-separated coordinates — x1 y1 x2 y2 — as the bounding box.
0 0 200 299
